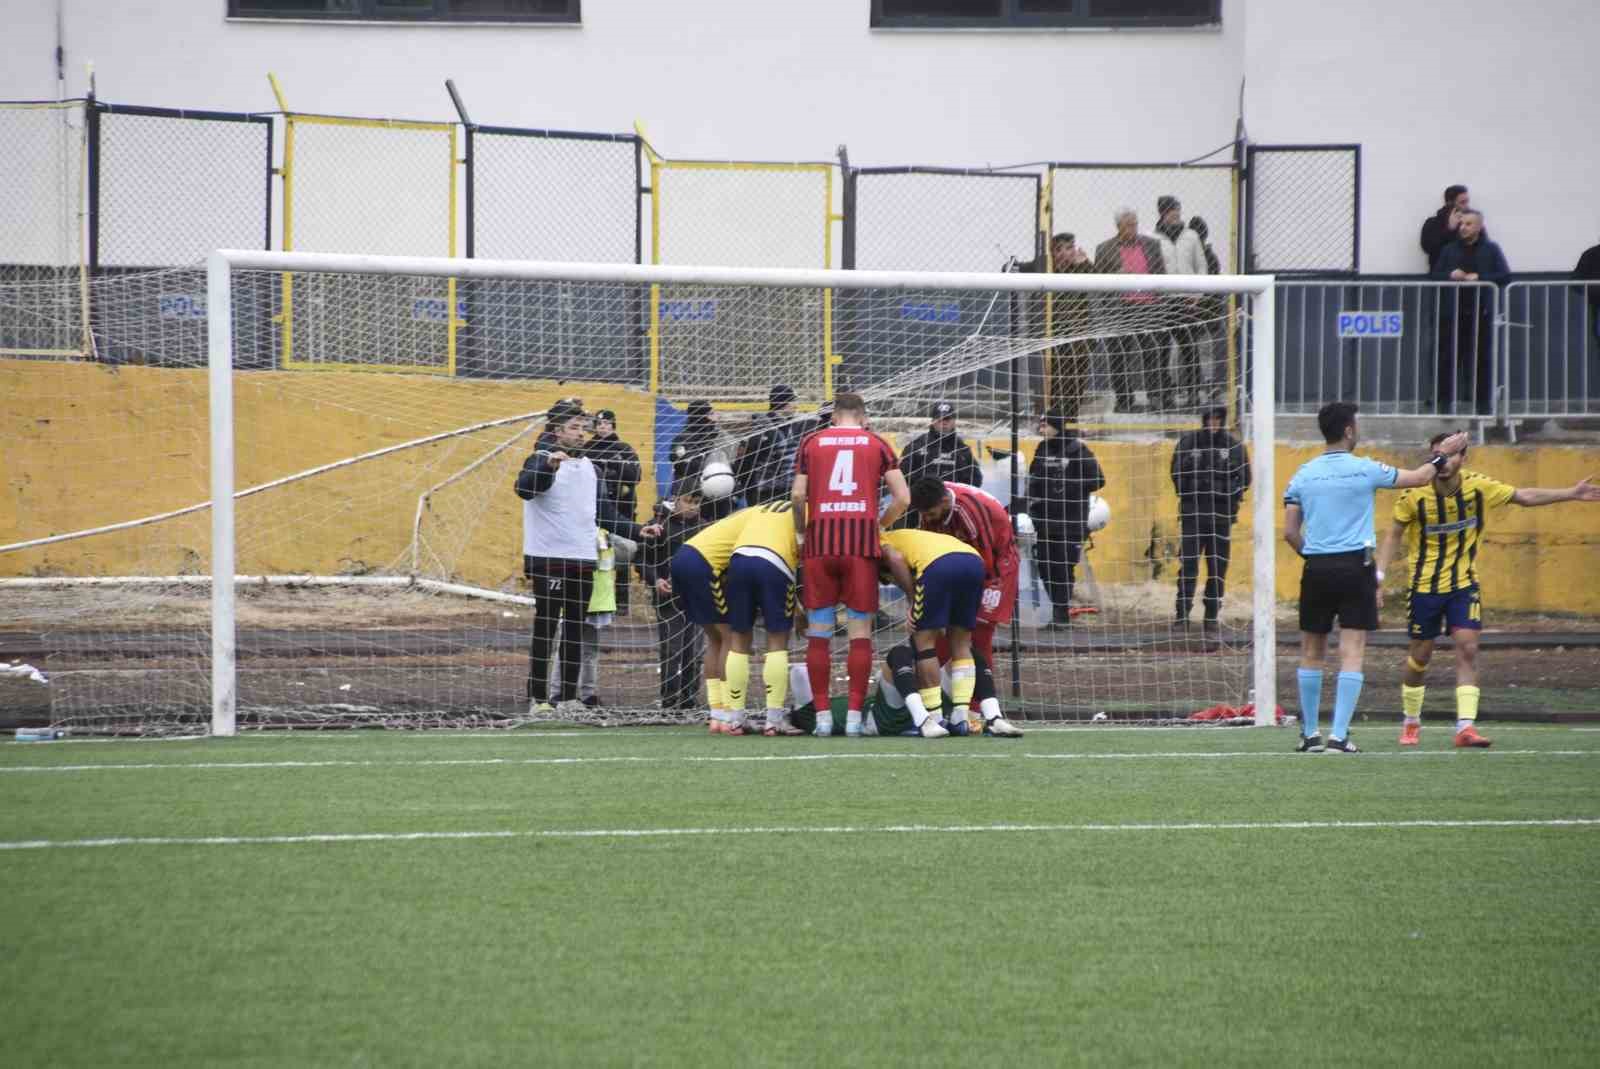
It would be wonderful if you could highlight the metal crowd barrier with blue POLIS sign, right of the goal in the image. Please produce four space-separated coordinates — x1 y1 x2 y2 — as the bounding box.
1274 280 1504 424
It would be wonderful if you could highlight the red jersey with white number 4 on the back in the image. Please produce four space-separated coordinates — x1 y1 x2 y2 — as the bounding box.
795 427 899 559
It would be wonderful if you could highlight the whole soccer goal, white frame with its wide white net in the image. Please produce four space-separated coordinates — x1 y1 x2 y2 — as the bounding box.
0 253 1272 733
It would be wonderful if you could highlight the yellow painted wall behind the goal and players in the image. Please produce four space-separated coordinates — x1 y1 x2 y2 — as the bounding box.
0 360 1600 613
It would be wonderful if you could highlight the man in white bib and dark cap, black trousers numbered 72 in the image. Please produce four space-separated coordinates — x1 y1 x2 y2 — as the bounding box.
517 398 600 714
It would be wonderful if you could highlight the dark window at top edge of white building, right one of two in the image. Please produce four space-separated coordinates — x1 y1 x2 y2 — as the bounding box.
870 0 1222 29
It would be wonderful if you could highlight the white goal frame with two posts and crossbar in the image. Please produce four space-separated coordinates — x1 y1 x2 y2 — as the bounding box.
193 250 1277 736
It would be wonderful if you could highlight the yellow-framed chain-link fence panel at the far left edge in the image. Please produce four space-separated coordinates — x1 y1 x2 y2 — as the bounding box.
0 101 90 357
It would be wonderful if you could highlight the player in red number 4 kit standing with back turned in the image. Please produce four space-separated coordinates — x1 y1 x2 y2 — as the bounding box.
790 394 910 736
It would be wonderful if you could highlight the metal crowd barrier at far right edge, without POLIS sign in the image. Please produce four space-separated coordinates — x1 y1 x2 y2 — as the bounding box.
1499 282 1600 434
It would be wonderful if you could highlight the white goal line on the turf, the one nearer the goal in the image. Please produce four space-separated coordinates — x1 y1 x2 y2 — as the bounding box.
0 749 1600 775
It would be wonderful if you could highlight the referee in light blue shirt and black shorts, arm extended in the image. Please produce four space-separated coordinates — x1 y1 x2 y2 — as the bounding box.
1283 402 1467 754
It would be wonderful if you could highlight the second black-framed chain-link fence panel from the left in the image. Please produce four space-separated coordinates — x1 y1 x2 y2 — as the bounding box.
456 126 650 386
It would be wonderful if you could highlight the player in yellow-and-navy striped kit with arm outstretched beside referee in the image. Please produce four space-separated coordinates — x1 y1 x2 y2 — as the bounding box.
1378 434 1600 747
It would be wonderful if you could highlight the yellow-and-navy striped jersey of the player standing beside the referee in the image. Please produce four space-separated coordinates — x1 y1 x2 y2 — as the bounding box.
1394 470 1517 594
